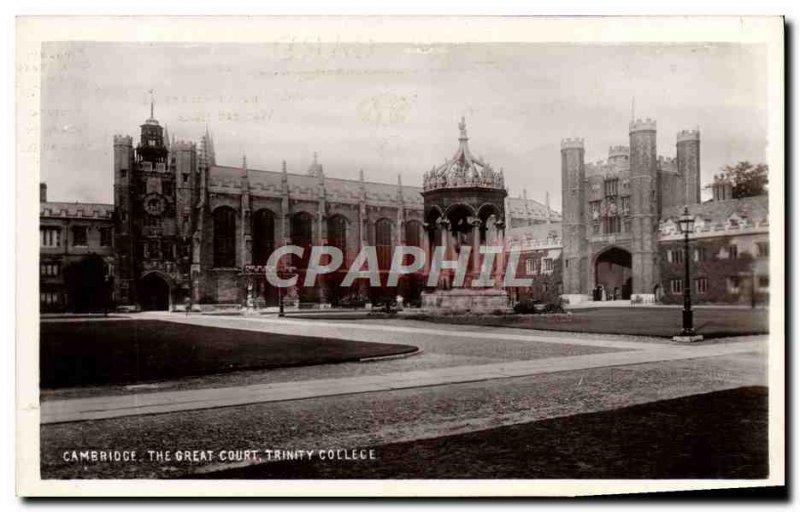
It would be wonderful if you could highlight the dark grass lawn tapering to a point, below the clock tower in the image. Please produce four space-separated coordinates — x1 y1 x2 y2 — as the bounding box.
39 320 417 389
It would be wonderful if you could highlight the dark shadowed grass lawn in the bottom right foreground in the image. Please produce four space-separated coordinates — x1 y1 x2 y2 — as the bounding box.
200 387 768 479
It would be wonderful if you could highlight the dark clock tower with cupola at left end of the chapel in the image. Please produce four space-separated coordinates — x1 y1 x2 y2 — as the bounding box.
114 97 197 310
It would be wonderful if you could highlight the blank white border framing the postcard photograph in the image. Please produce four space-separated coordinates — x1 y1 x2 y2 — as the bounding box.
16 16 786 497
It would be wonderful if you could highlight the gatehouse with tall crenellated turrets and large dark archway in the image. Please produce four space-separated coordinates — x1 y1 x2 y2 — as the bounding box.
561 119 700 302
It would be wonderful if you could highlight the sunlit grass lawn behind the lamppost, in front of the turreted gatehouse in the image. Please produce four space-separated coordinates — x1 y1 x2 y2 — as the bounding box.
411 307 769 338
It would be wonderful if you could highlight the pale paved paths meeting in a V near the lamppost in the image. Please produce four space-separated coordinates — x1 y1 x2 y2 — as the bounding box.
41 315 766 424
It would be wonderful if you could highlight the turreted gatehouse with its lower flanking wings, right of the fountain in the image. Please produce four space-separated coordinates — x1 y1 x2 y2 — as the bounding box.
508 119 769 304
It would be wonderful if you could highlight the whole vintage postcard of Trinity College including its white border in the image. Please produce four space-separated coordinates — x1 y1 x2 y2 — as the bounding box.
16 17 785 496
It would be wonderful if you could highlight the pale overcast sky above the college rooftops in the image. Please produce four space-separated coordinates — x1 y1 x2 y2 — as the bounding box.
41 43 767 209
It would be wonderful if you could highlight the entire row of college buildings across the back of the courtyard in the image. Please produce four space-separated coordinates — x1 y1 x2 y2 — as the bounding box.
40 110 769 312
